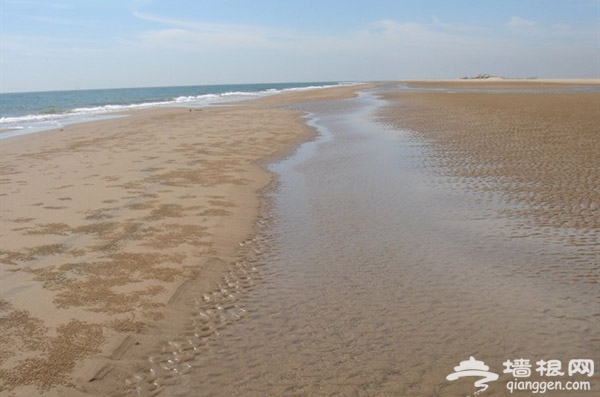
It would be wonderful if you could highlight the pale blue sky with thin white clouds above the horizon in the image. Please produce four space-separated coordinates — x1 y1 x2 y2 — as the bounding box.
0 0 600 92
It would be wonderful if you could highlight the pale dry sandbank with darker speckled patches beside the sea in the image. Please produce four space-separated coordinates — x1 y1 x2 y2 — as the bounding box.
0 83 368 395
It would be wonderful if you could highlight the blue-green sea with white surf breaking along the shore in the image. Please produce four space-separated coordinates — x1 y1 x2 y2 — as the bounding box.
0 81 354 139
